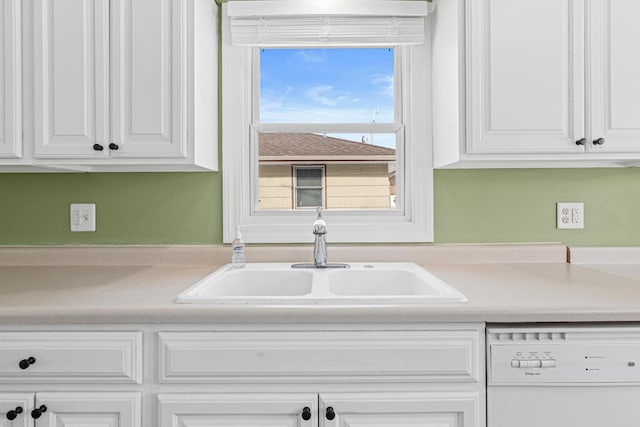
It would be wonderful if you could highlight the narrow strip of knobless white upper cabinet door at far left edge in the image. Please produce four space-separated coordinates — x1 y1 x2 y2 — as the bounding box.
0 0 22 158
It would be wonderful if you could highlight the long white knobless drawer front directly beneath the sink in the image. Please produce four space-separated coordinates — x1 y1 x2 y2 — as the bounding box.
158 331 480 383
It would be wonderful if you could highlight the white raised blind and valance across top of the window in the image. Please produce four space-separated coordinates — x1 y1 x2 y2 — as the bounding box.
227 0 428 47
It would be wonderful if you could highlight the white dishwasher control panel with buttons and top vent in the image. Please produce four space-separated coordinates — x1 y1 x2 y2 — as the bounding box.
487 331 640 385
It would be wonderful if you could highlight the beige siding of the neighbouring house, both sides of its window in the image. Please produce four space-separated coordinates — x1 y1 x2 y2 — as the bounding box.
258 163 391 210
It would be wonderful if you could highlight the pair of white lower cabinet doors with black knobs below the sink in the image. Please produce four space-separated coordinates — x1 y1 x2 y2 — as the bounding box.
158 392 480 427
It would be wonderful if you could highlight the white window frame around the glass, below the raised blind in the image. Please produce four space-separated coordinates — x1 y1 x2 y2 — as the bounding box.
221 3 433 243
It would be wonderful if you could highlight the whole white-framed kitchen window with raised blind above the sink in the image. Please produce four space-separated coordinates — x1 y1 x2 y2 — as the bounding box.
222 0 433 243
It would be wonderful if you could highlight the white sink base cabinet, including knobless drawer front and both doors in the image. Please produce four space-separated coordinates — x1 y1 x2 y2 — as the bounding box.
156 325 485 427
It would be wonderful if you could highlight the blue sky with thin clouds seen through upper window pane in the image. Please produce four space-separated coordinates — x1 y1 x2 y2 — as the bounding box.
260 48 394 127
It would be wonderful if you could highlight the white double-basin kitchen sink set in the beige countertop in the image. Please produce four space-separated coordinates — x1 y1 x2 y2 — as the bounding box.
175 262 466 305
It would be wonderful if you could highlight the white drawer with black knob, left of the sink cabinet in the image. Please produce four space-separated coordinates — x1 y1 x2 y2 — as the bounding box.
0 332 142 384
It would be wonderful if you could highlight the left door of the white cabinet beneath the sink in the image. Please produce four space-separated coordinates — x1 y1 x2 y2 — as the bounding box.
158 393 318 427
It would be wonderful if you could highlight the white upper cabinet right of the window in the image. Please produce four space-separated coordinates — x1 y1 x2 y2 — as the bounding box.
433 0 640 167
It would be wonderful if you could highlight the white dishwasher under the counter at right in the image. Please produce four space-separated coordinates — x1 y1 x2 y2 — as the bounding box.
487 325 640 427
